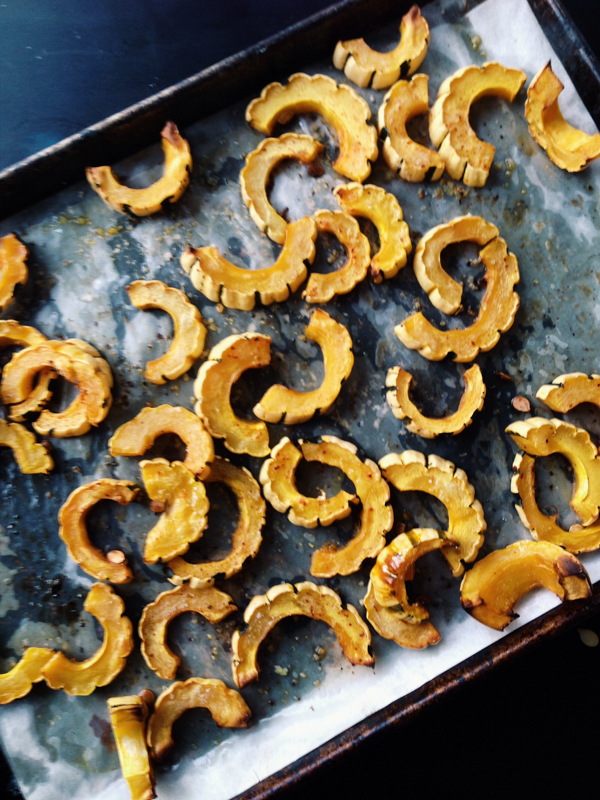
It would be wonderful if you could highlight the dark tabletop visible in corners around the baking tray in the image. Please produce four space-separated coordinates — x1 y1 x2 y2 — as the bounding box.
0 0 600 800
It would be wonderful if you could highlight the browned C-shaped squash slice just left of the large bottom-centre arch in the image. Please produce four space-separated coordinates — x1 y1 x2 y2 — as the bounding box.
138 586 237 681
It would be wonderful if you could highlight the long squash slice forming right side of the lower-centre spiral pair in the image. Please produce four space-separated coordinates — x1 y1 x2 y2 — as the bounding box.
302 436 394 578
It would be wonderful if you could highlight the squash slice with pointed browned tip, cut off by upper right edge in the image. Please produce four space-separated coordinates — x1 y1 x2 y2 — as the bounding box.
525 61 600 172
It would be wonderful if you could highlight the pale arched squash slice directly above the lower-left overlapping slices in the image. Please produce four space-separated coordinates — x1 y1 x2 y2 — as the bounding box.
108 404 215 478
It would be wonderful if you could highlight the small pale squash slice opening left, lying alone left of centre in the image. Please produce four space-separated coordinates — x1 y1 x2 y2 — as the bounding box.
127 281 206 384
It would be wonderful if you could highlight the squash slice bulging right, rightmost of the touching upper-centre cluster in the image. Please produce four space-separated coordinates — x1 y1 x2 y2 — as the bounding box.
333 183 412 283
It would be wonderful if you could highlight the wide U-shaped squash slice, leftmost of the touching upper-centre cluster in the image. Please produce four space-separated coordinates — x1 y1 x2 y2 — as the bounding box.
180 217 317 311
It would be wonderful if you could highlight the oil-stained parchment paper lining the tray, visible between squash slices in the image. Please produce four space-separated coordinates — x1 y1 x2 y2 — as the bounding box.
0 0 600 800
